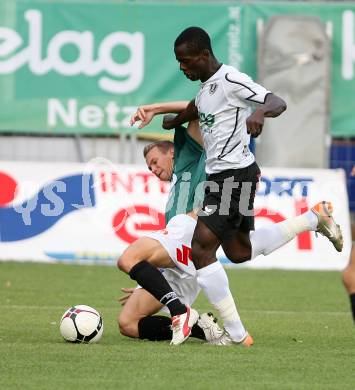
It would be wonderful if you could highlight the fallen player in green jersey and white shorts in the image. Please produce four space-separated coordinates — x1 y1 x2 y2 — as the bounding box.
117 102 223 342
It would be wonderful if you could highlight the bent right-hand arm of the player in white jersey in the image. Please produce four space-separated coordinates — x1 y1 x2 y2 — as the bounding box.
246 93 287 138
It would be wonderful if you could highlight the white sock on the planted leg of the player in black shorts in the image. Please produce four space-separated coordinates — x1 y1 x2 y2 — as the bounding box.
196 261 247 342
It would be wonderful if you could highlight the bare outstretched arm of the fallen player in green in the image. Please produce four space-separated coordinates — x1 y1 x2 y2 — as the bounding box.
130 101 189 129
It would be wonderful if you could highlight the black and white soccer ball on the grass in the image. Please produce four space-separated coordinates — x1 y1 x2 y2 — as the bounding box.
59 305 104 343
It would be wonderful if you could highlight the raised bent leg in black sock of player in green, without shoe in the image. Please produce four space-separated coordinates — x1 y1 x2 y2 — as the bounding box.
117 237 192 326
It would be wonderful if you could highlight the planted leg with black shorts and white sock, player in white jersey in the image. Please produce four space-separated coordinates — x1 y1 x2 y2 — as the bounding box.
192 164 260 345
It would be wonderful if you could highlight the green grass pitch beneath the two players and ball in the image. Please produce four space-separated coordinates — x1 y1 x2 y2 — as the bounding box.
0 262 355 390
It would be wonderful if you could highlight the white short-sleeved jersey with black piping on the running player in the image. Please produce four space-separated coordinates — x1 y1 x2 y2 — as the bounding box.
195 65 270 174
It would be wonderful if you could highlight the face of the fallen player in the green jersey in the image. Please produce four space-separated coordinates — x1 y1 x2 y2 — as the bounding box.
145 147 174 181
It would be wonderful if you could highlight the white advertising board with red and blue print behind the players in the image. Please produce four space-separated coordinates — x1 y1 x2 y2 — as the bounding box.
0 159 351 269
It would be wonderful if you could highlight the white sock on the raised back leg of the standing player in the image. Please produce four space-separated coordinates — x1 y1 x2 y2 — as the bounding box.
250 211 318 259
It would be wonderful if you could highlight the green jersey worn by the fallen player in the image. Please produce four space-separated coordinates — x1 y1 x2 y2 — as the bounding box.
165 126 206 223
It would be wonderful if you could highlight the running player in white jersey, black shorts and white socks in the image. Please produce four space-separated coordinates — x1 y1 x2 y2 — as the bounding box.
163 27 343 343
